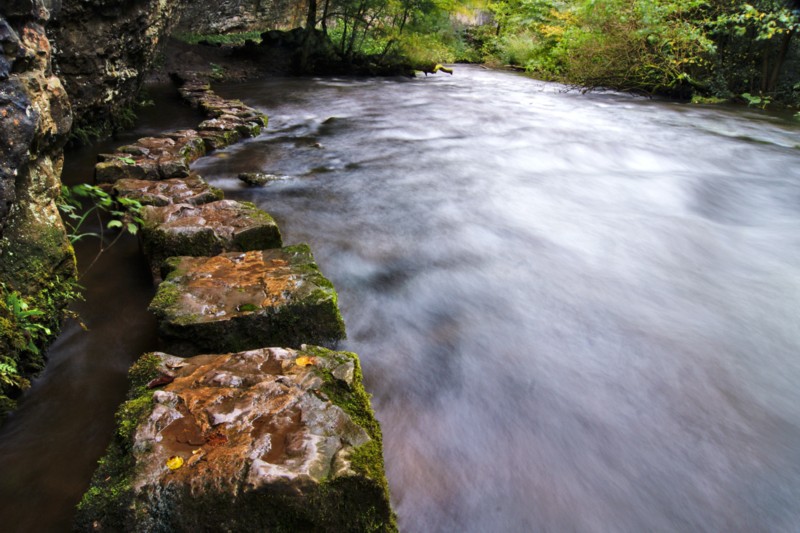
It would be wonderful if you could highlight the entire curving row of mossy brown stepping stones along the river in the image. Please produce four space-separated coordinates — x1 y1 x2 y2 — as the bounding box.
76 74 397 532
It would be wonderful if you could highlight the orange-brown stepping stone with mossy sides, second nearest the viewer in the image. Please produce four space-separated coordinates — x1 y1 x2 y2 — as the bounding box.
150 244 345 355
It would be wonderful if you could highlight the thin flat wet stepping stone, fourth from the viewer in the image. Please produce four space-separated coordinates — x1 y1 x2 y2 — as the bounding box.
112 174 223 206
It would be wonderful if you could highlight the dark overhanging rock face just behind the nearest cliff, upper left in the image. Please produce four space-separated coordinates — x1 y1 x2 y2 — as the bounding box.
52 0 185 139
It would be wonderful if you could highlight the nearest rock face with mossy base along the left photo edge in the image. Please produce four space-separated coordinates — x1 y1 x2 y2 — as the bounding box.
0 0 75 418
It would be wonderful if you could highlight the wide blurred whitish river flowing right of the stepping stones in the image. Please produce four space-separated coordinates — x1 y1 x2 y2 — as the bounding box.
0 66 800 533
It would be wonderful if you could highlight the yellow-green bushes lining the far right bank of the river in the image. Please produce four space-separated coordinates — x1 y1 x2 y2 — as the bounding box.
483 0 800 106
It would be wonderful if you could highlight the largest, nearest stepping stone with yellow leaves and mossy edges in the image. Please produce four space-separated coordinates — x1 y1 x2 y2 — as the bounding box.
76 347 396 532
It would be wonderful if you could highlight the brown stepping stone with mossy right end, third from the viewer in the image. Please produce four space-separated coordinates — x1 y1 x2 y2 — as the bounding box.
140 200 282 277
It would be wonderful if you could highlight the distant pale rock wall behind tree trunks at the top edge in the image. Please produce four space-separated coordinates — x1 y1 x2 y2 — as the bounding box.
177 0 305 35
